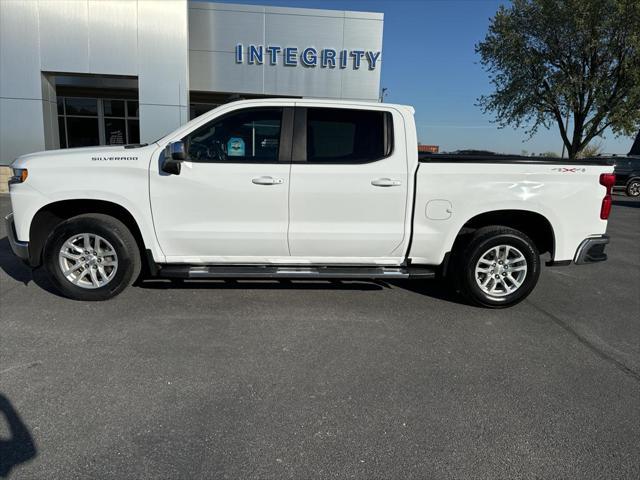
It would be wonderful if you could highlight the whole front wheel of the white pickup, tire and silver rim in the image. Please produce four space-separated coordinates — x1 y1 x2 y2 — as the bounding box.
44 213 141 301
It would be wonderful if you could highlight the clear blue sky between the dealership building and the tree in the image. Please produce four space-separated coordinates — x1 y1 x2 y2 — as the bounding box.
211 0 633 155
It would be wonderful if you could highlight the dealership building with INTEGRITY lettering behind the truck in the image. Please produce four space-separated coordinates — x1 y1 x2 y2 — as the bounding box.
0 0 383 186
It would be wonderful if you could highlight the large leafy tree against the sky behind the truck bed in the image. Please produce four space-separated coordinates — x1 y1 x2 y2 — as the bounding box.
476 0 640 158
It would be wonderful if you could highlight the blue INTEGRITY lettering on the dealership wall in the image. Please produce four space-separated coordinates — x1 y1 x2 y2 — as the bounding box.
236 44 381 70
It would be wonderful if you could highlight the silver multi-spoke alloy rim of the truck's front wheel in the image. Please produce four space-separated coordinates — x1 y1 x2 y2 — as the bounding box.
58 233 118 289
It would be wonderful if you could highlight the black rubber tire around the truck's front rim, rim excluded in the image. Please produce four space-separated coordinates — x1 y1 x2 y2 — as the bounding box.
43 213 141 301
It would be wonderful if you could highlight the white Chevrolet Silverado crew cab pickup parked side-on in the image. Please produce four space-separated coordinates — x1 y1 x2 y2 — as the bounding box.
7 99 615 307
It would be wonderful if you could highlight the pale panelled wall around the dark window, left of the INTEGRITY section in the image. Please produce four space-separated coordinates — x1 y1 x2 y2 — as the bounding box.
0 0 189 165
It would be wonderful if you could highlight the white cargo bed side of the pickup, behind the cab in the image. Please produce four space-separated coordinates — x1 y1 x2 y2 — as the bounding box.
409 153 613 265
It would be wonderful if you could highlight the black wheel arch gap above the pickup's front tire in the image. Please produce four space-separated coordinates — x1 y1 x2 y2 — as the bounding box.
29 199 148 267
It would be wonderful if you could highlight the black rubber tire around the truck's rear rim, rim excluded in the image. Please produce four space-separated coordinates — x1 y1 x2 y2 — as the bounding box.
451 225 540 308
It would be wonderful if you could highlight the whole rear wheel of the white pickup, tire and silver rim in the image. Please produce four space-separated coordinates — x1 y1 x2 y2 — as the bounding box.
453 226 540 308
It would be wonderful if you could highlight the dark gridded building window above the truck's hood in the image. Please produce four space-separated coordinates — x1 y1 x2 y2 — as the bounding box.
58 97 140 148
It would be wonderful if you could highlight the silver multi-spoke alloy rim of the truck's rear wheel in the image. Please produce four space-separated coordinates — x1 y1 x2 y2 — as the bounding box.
475 245 527 297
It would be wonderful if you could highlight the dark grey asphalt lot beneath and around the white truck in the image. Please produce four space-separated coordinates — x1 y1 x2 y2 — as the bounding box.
0 196 640 480
